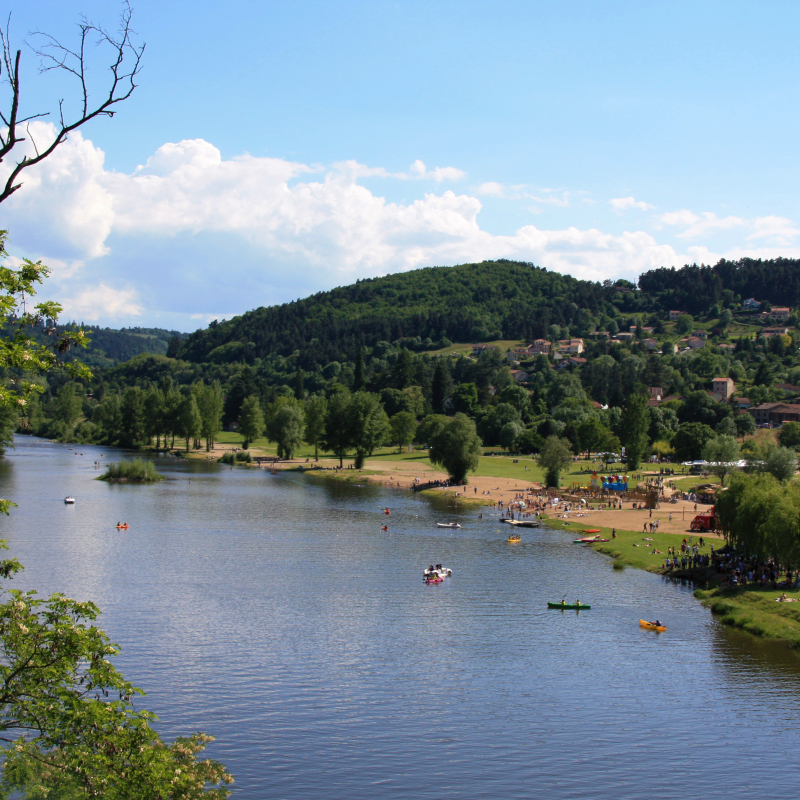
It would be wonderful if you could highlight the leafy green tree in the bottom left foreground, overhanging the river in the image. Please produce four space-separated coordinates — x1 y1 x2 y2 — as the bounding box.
0 548 232 800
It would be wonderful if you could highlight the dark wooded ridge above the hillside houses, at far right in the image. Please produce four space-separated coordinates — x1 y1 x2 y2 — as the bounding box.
639 258 800 314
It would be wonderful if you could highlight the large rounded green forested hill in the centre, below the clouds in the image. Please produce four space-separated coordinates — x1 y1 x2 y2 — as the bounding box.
175 260 609 364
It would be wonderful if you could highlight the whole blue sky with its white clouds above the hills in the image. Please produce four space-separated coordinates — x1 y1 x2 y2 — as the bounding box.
0 0 800 330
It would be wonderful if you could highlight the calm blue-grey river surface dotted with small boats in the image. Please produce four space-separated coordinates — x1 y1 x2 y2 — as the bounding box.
0 438 800 800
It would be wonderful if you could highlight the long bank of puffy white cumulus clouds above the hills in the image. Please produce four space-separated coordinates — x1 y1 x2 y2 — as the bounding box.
3 119 797 325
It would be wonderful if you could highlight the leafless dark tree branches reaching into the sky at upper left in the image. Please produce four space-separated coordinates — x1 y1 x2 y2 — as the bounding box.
0 0 145 203
